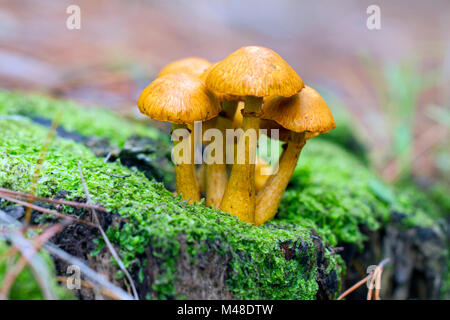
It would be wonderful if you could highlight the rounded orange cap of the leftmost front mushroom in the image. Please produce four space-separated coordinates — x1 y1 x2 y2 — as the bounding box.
137 73 220 123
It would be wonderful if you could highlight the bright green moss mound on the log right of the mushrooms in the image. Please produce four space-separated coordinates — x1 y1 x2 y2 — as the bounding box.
277 139 439 247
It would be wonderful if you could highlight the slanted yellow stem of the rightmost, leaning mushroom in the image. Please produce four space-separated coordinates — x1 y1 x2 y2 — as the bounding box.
255 132 306 225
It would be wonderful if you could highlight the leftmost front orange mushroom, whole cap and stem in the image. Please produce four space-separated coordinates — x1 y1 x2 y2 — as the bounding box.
137 73 220 202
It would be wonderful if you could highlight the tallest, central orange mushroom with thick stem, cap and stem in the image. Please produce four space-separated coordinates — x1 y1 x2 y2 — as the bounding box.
205 46 303 222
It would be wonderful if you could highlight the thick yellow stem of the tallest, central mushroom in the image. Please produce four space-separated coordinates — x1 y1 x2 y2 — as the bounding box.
220 96 263 223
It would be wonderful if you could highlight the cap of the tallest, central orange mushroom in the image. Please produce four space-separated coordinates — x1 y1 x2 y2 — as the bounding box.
206 46 303 97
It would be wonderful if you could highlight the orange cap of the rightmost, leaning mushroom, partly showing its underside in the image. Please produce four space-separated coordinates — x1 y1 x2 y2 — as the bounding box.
261 86 336 137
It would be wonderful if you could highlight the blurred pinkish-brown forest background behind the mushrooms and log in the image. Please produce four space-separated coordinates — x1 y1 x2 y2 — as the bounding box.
0 0 450 187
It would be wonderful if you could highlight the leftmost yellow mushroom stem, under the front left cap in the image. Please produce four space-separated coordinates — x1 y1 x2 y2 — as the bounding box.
172 124 200 203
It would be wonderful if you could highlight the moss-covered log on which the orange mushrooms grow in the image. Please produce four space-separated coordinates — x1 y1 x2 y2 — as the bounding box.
0 92 446 299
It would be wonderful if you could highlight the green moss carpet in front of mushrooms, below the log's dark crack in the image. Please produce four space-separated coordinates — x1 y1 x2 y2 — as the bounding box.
0 119 324 299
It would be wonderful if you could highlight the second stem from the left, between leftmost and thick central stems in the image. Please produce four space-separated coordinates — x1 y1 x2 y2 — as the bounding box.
206 116 230 208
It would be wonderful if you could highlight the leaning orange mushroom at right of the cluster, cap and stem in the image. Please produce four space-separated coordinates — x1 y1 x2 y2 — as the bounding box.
255 86 336 225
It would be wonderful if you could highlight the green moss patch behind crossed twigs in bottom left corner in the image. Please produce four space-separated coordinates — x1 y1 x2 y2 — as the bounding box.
0 240 73 300
